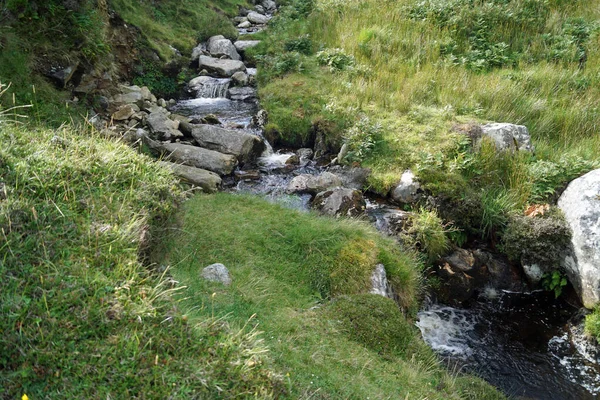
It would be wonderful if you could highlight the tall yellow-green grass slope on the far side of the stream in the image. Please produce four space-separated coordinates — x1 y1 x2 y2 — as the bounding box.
258 0 600 240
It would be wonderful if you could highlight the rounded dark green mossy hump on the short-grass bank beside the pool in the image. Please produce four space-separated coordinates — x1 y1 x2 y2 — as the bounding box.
326 294 414 356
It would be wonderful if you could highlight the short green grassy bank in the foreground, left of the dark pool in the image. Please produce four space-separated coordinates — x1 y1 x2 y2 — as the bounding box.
156 194 501 399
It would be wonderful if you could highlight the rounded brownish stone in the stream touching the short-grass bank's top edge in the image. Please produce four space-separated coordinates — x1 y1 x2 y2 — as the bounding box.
313 188 367 217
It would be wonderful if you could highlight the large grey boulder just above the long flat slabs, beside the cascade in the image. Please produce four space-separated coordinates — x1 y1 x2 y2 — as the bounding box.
192 125 265 163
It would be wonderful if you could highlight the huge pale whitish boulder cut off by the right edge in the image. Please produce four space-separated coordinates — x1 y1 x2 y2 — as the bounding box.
558 169 600 308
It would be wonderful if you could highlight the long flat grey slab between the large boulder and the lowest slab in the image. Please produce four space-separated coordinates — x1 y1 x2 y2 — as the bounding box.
143 137 238 175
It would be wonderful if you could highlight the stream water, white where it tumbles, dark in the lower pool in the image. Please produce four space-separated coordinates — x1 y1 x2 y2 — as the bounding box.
172 37 600 400
